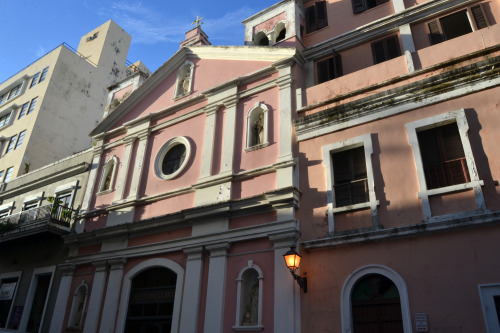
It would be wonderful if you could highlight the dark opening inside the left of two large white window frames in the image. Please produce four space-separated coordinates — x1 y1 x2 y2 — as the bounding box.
332 147 369 207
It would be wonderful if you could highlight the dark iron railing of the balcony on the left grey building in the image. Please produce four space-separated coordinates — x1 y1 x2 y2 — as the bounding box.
0 204 76 234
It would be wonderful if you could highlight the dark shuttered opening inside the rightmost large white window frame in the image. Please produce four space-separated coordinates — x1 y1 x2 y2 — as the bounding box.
417 123 470 189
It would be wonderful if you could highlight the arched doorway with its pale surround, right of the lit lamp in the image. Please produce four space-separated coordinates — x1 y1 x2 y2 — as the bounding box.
341 265 412 333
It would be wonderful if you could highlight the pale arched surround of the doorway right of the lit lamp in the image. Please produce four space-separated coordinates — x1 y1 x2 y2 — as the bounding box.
341 265 412 333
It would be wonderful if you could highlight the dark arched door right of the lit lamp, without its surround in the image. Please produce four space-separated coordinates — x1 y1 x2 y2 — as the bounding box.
351 274 404 333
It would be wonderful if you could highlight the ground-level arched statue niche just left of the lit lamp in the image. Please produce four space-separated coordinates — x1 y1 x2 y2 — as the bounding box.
233 260 264 330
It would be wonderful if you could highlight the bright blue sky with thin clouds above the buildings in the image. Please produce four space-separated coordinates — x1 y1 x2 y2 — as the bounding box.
0 0 279 82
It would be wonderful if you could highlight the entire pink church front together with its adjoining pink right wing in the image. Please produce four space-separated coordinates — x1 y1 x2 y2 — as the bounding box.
46 0 500 333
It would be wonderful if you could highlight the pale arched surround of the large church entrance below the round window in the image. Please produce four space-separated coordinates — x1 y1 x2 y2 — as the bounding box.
116 258 184 333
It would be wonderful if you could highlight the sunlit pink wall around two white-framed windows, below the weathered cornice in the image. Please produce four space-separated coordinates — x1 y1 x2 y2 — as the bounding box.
299 88 500 236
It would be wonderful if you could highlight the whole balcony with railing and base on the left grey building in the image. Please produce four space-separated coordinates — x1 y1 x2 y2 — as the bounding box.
0 204 76 244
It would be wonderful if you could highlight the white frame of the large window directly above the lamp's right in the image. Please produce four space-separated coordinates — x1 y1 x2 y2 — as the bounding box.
322 134 380 234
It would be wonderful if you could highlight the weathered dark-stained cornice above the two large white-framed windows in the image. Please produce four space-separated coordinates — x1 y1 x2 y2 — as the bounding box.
294 52 500 141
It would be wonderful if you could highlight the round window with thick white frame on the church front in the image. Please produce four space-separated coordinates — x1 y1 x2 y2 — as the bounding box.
155 136 191 180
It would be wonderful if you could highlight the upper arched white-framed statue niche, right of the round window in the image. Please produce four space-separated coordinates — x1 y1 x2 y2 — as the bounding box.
246 103 269 148
